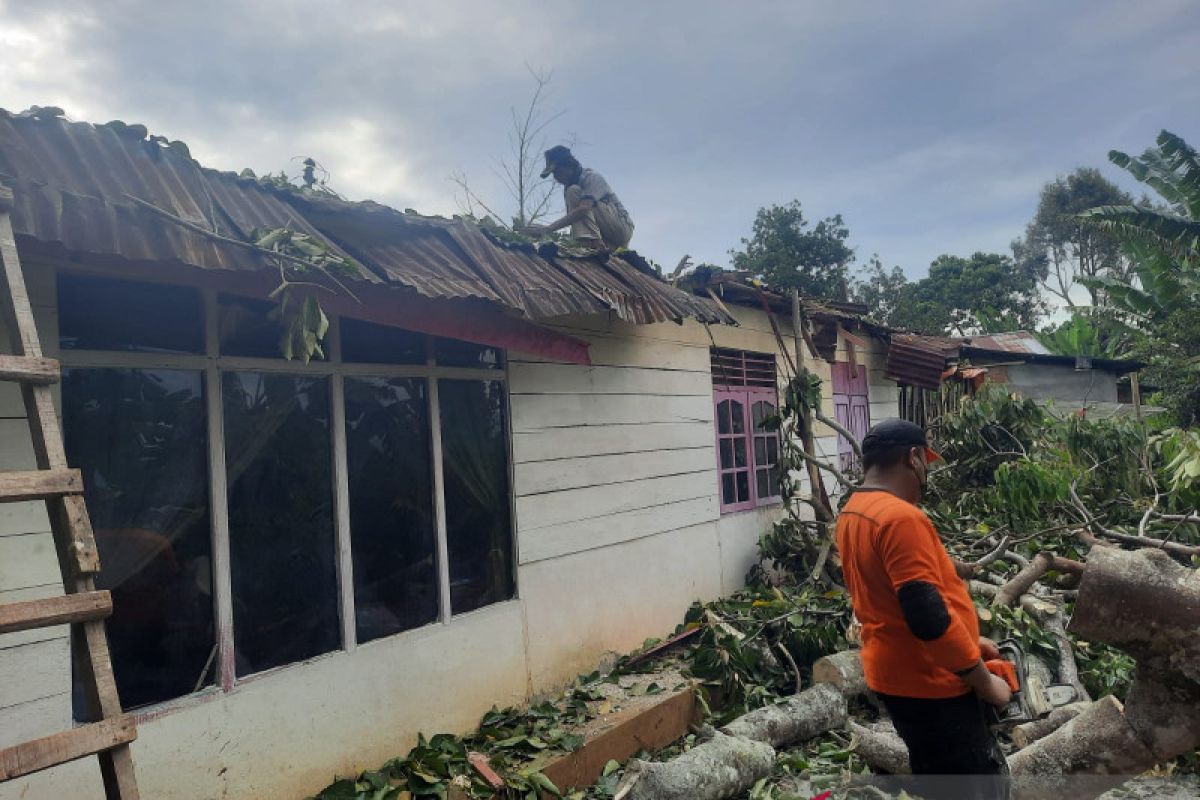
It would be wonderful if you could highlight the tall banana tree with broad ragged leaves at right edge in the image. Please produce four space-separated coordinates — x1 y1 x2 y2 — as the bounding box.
1078 131 1200 426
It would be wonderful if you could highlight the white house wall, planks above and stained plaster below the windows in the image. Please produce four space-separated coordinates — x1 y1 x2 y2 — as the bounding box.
0 267 849 800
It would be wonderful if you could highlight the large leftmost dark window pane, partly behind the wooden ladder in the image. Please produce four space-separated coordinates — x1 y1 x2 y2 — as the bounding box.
62 369 216 718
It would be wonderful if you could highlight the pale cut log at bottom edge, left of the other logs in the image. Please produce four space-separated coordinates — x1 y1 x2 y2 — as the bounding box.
614 732 775 800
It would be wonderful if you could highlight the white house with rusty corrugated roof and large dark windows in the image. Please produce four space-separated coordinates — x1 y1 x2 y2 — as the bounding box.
0 112 895 800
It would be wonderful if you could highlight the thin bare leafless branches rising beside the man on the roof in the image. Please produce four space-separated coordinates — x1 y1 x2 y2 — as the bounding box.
451 65 563 230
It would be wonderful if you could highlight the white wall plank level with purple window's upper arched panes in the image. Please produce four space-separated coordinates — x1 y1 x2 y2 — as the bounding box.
512 393 713 432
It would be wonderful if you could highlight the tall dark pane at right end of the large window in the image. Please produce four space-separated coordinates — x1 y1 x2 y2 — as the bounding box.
438 380 515 614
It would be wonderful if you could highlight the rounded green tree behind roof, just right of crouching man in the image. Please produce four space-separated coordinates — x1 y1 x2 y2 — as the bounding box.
730 200 854 300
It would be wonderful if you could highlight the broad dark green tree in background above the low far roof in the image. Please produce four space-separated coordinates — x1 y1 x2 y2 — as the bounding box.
888 253 1045 336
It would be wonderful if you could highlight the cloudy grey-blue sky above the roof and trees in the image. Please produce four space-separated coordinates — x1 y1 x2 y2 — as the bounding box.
0 0 1200 276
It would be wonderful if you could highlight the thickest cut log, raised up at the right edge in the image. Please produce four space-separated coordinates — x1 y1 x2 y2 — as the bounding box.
1070 547 1200 684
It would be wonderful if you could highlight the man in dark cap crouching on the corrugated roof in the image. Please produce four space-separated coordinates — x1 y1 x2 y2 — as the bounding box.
524 145 634 251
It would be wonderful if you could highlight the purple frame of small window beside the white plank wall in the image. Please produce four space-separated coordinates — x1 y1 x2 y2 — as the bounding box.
710 348 784 515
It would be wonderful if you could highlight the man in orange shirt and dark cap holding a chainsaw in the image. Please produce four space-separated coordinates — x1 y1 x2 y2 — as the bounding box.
838 420 1010 800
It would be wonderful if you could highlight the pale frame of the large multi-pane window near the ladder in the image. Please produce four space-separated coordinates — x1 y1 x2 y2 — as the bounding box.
52 264 521 718
